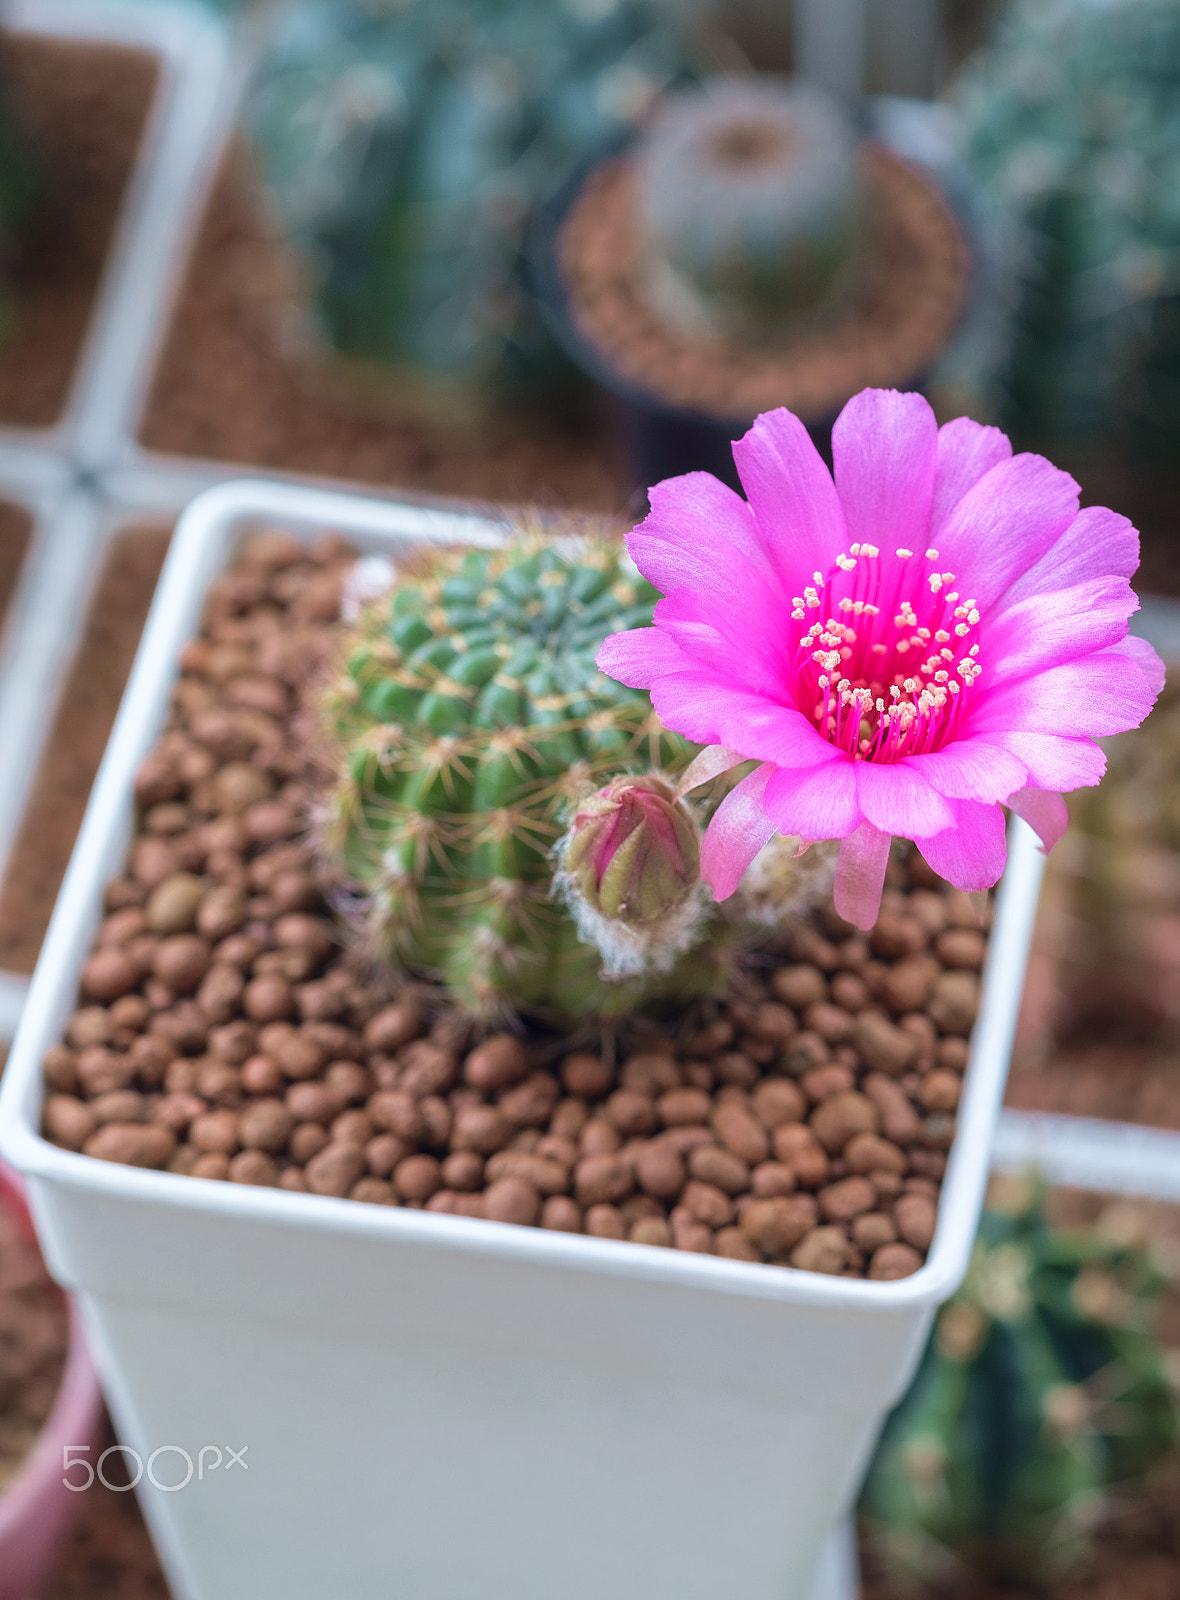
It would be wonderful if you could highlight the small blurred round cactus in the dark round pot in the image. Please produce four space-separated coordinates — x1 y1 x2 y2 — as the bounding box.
635 77 865 341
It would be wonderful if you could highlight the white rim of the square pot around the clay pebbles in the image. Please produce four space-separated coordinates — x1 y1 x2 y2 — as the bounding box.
0 480 1041 1315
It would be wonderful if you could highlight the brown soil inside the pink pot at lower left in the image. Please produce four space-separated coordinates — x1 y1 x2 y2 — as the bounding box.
0 1205 69 1493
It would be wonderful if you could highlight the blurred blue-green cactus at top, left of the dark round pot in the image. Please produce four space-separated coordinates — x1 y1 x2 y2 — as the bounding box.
246 0 689 406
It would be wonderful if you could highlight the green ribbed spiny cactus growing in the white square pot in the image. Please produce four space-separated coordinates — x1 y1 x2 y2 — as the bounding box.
323 536 726 1019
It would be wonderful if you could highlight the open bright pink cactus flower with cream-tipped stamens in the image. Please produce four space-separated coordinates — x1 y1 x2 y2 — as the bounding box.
598 389 1164 928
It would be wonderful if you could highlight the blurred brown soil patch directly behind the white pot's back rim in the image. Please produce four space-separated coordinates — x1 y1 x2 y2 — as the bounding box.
141 150 632 514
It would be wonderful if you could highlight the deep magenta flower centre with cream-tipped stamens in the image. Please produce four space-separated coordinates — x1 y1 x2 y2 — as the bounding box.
791 544 983 762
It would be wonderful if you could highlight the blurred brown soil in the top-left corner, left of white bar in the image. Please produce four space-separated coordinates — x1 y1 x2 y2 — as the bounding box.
0 34 158 427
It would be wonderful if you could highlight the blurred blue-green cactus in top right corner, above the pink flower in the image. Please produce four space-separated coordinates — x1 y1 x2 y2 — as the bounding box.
953 0 1180 453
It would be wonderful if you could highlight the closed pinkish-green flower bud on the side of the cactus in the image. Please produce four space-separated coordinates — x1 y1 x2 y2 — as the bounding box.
561 776 700 928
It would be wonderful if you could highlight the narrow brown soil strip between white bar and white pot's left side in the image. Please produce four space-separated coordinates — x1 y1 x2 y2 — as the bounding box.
0 526 171 973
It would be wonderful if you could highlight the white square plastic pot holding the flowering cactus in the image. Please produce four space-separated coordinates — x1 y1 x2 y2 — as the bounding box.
0 482 1039 1600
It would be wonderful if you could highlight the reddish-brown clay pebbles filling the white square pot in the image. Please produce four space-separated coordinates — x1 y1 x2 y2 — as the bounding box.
36 533 985 1278
